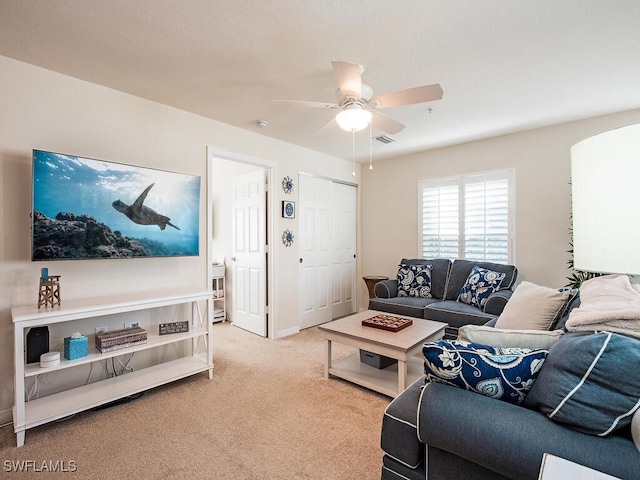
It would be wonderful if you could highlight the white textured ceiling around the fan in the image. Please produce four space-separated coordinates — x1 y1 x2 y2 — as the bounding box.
0 0 640 161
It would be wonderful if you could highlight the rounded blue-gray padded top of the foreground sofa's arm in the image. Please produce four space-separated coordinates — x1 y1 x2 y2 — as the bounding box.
418 383 640 479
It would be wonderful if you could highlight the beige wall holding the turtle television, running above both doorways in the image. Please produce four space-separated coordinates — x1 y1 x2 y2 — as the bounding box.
0 57 360 423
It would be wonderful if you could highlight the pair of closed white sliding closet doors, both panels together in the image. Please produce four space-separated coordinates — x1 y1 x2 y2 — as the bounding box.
298 175 356 328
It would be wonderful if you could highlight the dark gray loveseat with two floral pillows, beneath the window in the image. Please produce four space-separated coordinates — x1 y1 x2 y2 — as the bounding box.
369 258 518 338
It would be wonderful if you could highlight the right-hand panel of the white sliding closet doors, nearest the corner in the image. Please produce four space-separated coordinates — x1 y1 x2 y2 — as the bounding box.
331 183 357 318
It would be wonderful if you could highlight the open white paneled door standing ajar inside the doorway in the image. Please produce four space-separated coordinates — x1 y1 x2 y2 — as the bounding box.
231 169 267 337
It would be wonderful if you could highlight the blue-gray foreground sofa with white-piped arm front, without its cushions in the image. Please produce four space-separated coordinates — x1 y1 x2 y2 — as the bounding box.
381 376 640 480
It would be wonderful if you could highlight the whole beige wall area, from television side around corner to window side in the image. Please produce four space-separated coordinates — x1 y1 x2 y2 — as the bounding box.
0 53 640 421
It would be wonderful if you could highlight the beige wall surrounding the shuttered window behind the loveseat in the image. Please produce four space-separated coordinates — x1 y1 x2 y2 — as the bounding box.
360 110 640 306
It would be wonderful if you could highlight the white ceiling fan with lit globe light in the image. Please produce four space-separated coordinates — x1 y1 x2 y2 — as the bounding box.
276 61 443 134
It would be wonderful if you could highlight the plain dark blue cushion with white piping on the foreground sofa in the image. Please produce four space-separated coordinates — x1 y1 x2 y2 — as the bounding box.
525 332 640 436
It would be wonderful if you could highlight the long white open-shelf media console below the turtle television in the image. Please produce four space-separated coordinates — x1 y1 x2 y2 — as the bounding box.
11 289 213 447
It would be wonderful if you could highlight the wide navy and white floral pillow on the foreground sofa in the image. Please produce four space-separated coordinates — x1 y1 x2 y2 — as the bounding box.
422 340 548 405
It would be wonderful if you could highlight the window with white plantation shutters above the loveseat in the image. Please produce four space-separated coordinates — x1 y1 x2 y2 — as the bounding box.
419 170 514 263
